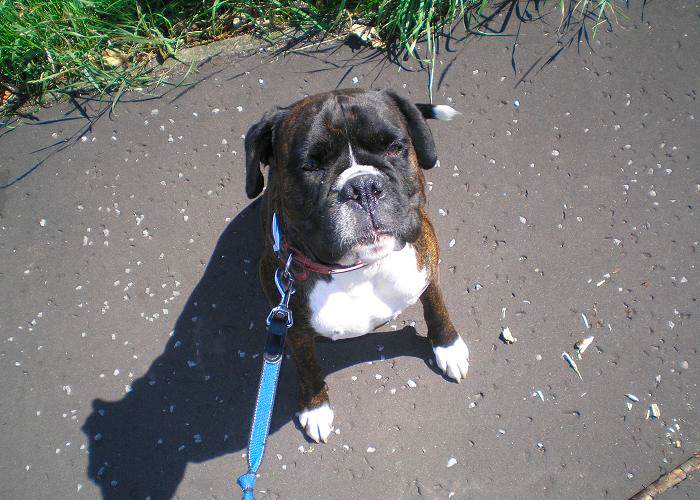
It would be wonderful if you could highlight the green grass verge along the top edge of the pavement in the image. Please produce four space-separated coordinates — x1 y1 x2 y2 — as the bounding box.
0 0 622 114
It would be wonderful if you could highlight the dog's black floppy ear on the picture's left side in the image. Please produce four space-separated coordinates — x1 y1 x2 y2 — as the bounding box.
245 108 284 198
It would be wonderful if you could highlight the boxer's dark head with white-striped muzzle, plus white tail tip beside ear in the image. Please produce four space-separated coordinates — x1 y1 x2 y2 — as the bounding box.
245 89 456 264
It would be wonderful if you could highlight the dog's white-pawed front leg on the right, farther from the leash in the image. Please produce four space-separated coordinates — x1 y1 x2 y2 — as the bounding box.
420 281 469 383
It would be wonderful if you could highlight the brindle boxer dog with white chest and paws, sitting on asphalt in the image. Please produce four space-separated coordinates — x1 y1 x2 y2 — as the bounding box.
245 89 469 442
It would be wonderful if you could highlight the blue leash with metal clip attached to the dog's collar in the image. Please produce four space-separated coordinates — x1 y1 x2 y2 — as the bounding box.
238 214 294 500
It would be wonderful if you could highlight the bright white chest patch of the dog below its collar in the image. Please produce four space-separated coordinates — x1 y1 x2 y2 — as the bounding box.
309 244 428 340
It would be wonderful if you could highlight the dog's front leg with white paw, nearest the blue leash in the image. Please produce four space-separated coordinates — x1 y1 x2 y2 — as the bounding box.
287 325 333 443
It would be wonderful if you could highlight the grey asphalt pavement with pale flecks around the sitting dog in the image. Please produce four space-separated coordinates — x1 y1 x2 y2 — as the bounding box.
0 1 700 500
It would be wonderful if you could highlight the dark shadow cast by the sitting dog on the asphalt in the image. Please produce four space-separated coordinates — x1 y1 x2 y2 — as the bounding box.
82 199 429 499
